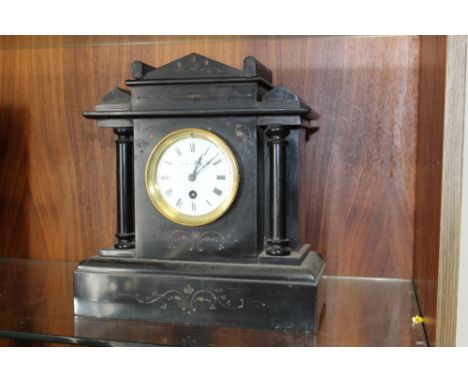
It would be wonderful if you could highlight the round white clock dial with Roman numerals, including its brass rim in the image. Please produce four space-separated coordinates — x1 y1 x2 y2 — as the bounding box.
146 128 239 226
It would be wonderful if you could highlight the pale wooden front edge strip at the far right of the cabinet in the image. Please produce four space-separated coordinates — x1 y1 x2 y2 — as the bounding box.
436 36 467 346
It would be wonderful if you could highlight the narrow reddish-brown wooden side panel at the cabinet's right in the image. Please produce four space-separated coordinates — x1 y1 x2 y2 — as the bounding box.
413 36 447 345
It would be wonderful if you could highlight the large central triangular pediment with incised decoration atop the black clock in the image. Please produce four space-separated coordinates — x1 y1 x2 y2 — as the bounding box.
143 53 245 80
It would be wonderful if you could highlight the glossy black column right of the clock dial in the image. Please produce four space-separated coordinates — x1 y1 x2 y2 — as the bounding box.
266 125 291 256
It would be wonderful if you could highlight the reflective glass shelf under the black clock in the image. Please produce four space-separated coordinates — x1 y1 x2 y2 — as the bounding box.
0 257 426 346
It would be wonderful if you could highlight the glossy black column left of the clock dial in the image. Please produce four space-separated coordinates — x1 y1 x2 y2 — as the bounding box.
114 127 135 249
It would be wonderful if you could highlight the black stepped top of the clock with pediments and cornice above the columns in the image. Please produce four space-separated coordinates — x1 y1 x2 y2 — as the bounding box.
83 53 319 127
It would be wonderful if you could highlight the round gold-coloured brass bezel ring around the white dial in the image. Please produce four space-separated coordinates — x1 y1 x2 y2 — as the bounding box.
145 128 239 227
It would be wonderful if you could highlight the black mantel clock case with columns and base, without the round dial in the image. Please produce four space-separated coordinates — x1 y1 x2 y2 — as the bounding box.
74 53 325 331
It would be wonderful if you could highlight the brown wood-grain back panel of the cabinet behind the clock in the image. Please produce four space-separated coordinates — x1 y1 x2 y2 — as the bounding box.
0 36 419 278
